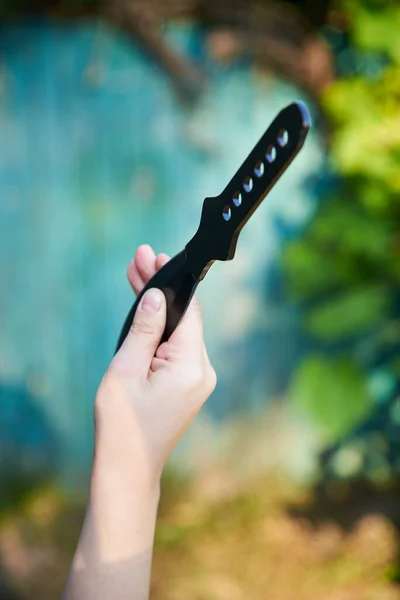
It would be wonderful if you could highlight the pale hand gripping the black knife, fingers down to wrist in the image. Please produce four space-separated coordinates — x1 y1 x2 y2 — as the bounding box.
95 246 216 488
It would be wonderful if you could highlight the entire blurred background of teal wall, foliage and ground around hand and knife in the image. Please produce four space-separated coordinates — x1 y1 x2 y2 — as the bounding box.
0 0 400 600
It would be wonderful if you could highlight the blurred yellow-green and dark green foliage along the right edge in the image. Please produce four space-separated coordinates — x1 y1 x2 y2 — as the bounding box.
283 0 400 438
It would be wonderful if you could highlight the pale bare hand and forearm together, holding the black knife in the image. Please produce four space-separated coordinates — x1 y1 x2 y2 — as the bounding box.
62 245 216 600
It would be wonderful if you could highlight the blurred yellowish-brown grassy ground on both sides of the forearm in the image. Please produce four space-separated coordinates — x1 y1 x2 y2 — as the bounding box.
0 476 400 600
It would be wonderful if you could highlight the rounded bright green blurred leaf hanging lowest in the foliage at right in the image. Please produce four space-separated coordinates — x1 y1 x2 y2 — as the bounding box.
290 355 370 440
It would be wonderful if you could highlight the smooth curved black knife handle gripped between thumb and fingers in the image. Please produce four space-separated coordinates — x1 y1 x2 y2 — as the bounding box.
115 250 198 352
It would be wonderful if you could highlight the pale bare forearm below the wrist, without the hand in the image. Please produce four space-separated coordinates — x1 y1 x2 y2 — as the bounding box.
63 432 159 600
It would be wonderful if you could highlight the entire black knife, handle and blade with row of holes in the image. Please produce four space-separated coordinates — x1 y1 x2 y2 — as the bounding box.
115 102 311 352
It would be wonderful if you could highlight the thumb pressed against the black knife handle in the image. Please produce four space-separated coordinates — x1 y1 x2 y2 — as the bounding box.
118 288 166 376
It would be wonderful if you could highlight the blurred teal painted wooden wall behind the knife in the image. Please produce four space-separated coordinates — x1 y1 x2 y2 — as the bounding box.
0 23 323 482
